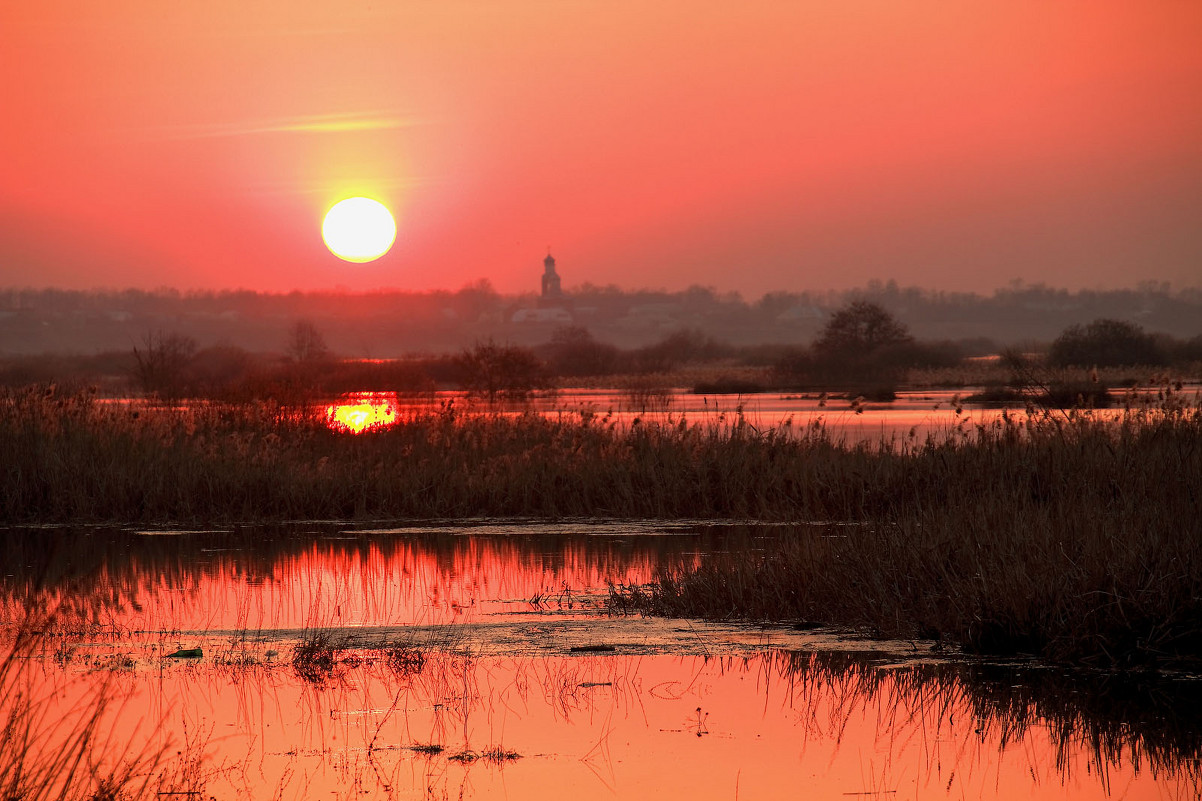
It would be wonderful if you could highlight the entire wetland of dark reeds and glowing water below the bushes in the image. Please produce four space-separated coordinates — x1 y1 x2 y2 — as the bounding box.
0 387 1202 799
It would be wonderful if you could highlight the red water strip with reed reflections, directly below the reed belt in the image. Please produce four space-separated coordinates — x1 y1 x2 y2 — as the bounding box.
0 524 701 639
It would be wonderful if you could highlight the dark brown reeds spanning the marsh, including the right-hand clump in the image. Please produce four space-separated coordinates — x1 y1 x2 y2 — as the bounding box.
7 380 1202 664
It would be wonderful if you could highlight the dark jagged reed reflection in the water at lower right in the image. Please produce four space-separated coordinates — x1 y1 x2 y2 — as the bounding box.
763 652 1202 791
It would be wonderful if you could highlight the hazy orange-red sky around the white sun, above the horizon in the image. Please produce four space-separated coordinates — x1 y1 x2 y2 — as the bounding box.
0 0 1202 297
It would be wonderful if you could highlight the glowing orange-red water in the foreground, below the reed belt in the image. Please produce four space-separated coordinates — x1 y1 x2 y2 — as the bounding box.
2 521 1202 800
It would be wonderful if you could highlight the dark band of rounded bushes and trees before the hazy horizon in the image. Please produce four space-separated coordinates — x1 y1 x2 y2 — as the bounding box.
0 299 1202 403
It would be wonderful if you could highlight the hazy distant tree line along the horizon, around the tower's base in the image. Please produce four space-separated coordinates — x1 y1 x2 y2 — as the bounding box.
0 280 1202 357
